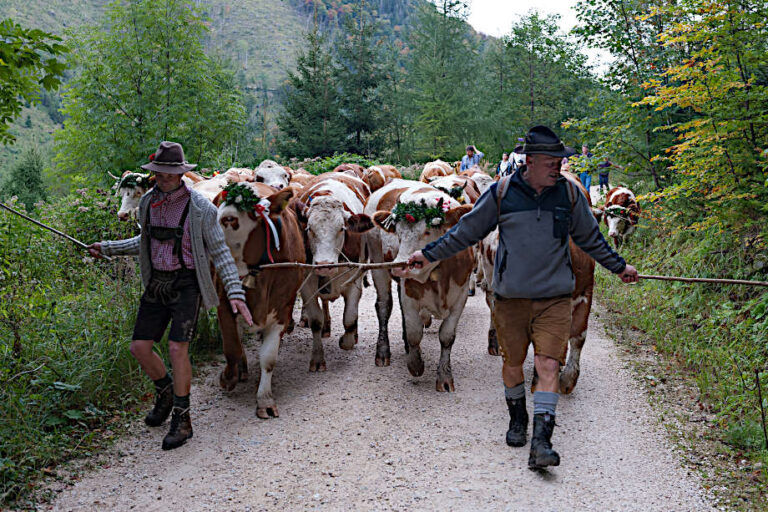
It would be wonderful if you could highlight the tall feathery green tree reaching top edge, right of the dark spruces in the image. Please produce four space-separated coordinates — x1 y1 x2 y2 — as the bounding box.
408 0 479 158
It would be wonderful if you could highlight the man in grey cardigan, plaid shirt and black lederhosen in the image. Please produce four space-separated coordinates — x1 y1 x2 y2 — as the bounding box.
88 142 252 450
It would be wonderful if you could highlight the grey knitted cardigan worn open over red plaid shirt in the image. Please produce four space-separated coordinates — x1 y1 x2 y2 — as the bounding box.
101 190 245 308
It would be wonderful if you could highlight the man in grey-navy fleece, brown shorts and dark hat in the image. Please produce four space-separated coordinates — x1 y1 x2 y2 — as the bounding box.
408 126 637 468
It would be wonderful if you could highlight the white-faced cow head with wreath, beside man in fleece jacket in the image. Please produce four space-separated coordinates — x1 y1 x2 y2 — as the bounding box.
373 192 472 283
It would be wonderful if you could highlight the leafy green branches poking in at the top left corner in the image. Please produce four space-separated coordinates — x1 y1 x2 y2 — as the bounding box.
0 18 67 144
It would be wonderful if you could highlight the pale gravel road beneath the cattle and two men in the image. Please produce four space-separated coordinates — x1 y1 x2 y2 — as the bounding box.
44 287 708 511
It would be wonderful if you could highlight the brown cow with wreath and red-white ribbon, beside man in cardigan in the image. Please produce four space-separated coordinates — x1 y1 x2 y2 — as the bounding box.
214 182 306 419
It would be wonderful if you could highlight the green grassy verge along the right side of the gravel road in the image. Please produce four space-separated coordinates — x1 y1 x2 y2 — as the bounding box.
596 215 768 509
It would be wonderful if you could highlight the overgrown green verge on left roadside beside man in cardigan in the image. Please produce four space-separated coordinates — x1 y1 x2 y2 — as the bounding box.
0 189 220 508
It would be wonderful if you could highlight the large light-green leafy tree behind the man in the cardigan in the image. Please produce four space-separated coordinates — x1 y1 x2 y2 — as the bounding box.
55 0 245 181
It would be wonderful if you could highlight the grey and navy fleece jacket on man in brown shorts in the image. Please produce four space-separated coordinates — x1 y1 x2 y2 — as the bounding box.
422 173 626 299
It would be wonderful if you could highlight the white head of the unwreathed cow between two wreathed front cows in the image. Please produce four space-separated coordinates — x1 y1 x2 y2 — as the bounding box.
299 196 373 276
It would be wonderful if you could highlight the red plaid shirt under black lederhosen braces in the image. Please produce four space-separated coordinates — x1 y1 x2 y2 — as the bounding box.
149 183 195 271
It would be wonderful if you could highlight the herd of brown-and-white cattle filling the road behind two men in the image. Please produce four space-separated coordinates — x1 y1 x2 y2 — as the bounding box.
111 160 639 418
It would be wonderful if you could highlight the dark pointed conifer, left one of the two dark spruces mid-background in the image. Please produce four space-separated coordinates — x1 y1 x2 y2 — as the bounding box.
277 17 345 157
